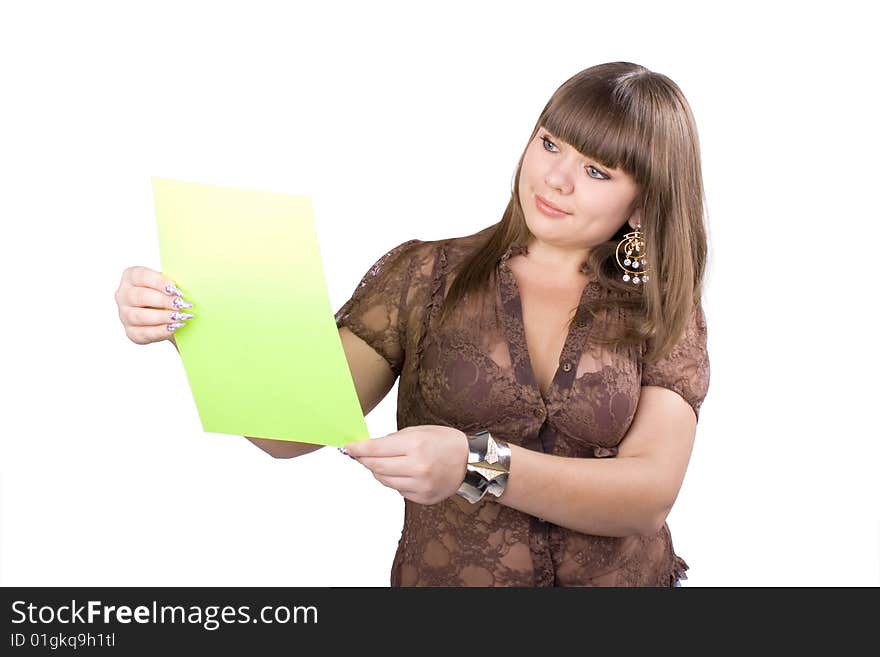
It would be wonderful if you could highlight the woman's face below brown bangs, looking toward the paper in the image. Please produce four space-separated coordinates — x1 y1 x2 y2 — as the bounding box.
519 126 639 249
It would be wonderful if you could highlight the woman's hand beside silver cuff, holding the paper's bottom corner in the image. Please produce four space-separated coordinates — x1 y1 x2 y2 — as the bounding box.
344 424 468 504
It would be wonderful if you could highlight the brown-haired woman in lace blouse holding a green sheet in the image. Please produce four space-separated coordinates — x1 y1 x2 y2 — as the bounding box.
117 62 709 586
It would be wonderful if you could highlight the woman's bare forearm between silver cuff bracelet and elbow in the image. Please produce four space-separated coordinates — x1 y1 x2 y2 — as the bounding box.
492 444 663 536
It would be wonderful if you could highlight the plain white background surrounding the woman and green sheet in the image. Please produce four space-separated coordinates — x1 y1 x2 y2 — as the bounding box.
0 0 880 586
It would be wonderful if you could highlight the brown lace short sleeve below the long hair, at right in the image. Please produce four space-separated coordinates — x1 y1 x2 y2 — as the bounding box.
642 302 709 422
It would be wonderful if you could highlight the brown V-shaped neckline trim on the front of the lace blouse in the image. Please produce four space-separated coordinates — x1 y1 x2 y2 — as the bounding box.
499 245 599 405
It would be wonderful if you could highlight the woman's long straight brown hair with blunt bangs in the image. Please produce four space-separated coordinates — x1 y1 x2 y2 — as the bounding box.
440 62 707 362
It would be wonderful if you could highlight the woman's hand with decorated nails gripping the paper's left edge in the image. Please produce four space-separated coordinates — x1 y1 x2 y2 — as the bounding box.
116 267 194 344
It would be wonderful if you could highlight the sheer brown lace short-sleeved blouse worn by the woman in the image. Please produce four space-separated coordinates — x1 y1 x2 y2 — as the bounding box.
335 227 709 587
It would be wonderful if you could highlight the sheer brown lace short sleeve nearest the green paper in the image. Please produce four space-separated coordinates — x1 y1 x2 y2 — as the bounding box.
335 239 422 376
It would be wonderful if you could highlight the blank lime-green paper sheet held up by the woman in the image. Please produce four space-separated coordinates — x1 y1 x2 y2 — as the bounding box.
152 178 369 446
